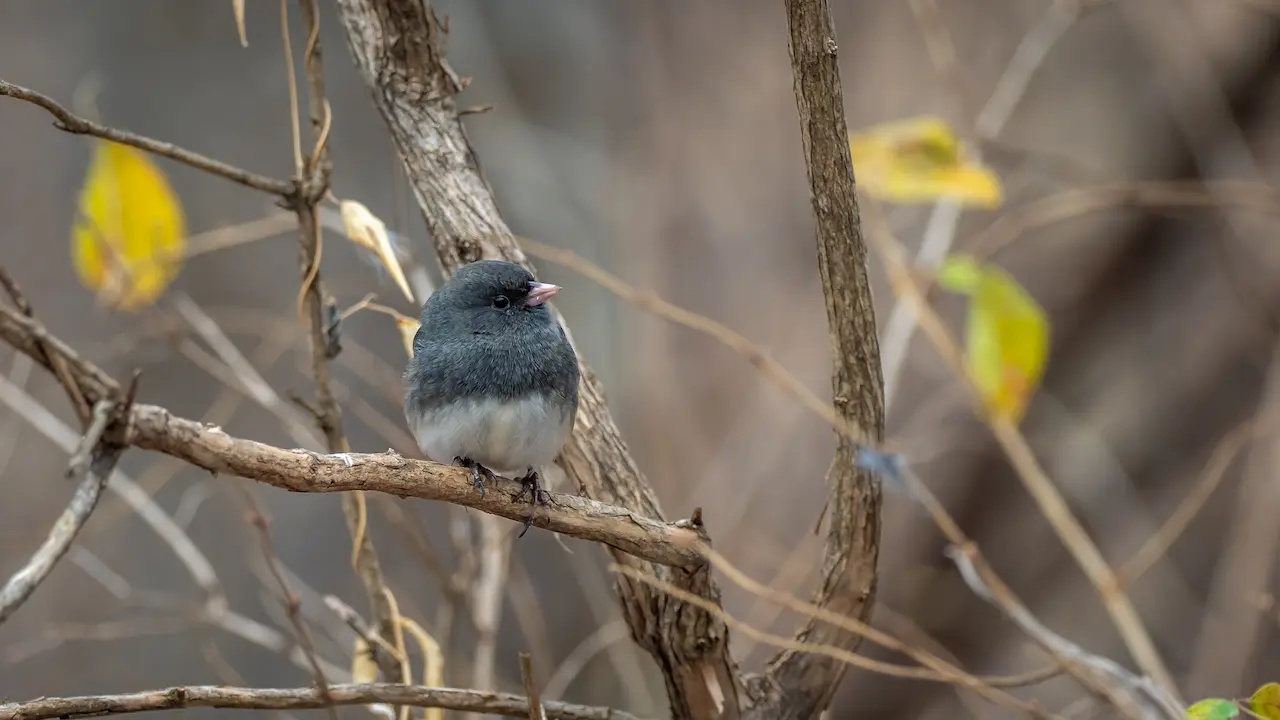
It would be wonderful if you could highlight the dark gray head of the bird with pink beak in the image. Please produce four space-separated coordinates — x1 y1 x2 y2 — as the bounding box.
422 260 559 334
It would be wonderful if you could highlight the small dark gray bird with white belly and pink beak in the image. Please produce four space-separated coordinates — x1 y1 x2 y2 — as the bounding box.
404 260 577 536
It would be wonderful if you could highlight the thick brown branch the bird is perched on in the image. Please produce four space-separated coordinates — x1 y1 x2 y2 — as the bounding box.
0 299 705 569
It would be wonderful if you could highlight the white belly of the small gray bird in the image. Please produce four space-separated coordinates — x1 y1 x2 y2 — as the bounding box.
410 396 572 478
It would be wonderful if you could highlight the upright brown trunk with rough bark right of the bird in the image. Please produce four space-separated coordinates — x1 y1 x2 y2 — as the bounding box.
756 0 884 719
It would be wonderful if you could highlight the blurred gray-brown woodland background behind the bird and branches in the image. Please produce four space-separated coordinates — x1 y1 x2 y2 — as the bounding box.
0 0 1280 719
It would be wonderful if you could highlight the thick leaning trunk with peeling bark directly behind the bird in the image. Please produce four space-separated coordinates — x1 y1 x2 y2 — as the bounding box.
338 0 740 720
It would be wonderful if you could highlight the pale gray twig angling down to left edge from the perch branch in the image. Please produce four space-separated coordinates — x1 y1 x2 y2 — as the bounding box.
0 400 123 623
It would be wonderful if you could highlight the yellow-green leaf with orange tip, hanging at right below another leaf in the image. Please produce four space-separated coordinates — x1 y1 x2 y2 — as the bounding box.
938 255 1050 423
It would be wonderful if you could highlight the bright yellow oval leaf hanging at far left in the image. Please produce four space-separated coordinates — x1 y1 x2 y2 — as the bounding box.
72 140 187 310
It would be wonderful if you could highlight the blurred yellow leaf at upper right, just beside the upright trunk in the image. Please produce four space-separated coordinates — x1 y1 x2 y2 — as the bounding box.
849 117 1004 208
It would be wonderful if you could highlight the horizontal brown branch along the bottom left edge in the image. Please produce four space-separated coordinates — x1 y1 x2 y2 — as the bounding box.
0 684 639 720
